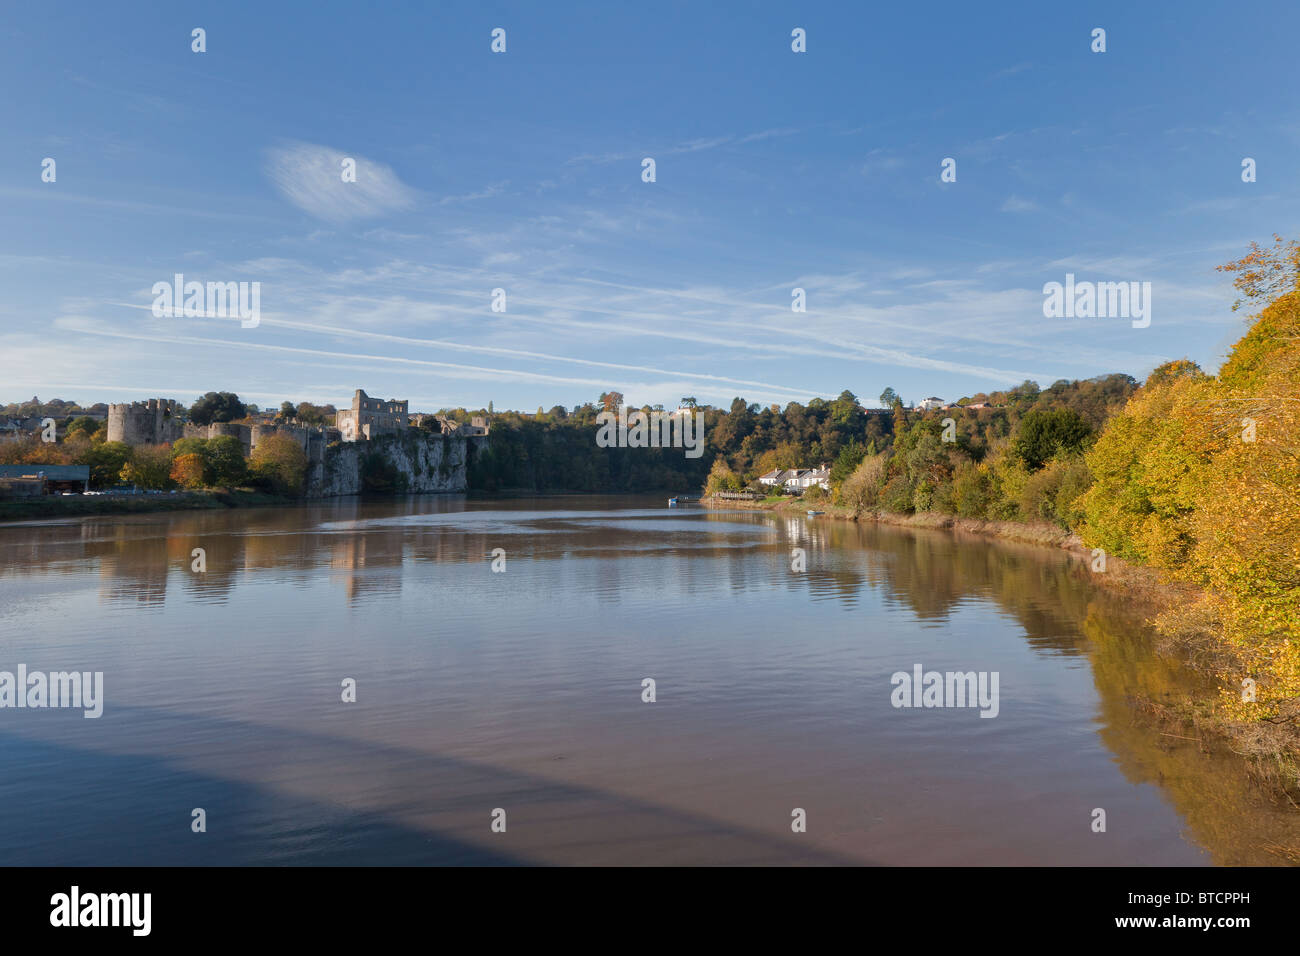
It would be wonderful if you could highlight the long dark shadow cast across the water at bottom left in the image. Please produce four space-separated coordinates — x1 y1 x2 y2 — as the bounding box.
0 708 863 866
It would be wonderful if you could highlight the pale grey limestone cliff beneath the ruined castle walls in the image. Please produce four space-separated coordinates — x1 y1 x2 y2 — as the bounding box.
307 429 486 498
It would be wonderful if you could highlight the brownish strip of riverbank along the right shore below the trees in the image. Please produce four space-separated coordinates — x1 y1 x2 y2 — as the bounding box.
699 497 1300 809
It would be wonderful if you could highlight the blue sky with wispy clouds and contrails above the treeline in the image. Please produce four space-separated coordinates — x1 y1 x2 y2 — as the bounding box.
0 0 1300 410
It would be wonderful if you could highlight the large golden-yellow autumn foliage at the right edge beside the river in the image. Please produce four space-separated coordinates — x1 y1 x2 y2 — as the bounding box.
1079 239 1300 721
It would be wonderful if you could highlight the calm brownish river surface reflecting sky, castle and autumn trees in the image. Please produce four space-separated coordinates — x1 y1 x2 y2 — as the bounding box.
0 498 1300 865
